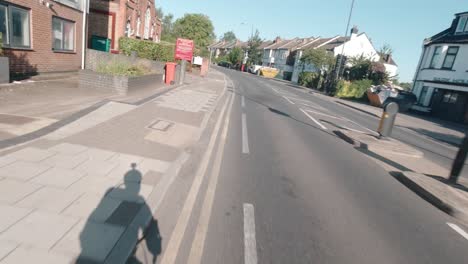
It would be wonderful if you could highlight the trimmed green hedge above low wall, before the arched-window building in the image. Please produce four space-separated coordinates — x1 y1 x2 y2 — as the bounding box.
119 37 174 62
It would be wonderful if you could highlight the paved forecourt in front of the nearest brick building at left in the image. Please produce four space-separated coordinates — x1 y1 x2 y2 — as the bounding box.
0 75 176 140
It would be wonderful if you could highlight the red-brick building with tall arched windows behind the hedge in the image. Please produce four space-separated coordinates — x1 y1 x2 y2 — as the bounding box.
88 0 161 50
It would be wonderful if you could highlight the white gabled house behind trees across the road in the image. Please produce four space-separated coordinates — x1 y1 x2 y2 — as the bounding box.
292 27 398 83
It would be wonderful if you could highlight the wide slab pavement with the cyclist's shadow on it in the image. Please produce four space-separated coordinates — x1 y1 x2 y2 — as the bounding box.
0 69 225 264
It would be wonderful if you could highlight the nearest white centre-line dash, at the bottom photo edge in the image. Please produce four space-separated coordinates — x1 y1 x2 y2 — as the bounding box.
244 203 258 264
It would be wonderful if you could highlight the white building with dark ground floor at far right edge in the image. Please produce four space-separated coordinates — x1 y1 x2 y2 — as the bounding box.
413 12 468 123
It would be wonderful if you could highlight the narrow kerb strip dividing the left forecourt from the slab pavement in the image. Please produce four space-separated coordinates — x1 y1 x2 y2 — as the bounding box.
0 85 184 151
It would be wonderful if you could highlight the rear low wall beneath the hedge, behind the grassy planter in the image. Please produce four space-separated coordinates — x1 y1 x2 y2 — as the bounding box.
85 49 165 73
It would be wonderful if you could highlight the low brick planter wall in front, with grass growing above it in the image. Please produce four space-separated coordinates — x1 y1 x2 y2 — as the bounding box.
79 70 164 95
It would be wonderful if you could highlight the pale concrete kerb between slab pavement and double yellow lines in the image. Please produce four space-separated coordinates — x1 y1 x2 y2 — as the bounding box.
104 68 228 263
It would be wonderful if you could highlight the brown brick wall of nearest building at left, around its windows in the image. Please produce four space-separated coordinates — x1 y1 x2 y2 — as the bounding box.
4 0 83 74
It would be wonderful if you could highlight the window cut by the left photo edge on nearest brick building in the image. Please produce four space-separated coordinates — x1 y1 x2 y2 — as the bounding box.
0 4 31 48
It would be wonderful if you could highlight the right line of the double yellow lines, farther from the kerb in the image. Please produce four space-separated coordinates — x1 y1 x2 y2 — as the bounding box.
187 86 234 264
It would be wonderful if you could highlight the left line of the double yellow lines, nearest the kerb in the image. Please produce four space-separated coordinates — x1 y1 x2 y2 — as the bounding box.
160 91 234 264
